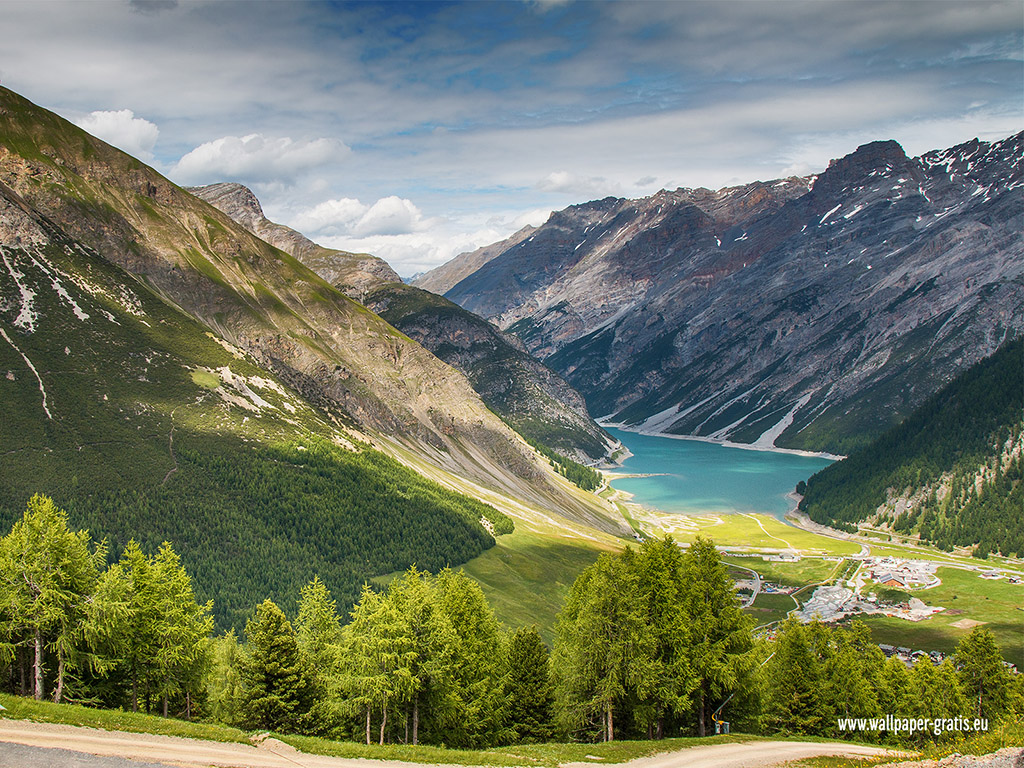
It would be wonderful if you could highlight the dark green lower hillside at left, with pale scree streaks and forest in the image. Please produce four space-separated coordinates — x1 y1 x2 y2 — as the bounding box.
0 189 512 629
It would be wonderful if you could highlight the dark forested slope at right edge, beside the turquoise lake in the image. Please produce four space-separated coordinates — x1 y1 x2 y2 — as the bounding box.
801 338 1024 557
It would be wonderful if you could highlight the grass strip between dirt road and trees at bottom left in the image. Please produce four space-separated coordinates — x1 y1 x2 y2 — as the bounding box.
0 693 249 743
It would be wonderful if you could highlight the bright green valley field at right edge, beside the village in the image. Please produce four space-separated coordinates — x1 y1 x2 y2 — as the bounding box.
859 567 1024 669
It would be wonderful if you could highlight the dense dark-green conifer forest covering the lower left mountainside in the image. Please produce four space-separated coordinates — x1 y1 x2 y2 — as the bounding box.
0 436 513 632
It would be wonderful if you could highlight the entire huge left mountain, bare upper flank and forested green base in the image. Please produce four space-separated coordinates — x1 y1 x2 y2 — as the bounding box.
0 89 628 627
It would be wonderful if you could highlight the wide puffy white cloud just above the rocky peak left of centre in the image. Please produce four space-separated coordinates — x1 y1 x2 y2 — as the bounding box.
172 133 348 183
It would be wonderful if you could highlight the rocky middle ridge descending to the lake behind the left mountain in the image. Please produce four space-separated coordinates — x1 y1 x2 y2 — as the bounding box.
190 183 612 462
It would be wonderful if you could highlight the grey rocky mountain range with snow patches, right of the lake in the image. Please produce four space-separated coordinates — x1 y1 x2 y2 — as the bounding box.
425 134 1024 452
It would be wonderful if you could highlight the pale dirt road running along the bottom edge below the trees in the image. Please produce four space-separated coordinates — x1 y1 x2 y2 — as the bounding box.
0 720 901 768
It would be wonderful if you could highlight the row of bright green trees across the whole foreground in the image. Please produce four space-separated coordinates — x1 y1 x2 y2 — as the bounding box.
0 496 1024 749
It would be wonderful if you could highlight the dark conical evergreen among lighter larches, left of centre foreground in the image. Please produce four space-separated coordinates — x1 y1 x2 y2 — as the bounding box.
240 600 313 732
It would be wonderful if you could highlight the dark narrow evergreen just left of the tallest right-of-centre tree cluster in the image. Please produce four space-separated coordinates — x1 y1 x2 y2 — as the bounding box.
506 627 554 743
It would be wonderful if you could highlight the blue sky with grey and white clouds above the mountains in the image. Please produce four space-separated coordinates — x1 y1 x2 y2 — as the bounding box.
0 0 1024 278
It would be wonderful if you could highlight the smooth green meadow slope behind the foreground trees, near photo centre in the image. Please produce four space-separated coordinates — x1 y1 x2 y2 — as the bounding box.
462 528 601 644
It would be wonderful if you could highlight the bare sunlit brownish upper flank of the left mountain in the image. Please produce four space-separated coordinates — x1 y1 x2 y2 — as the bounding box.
0 89 618 530
